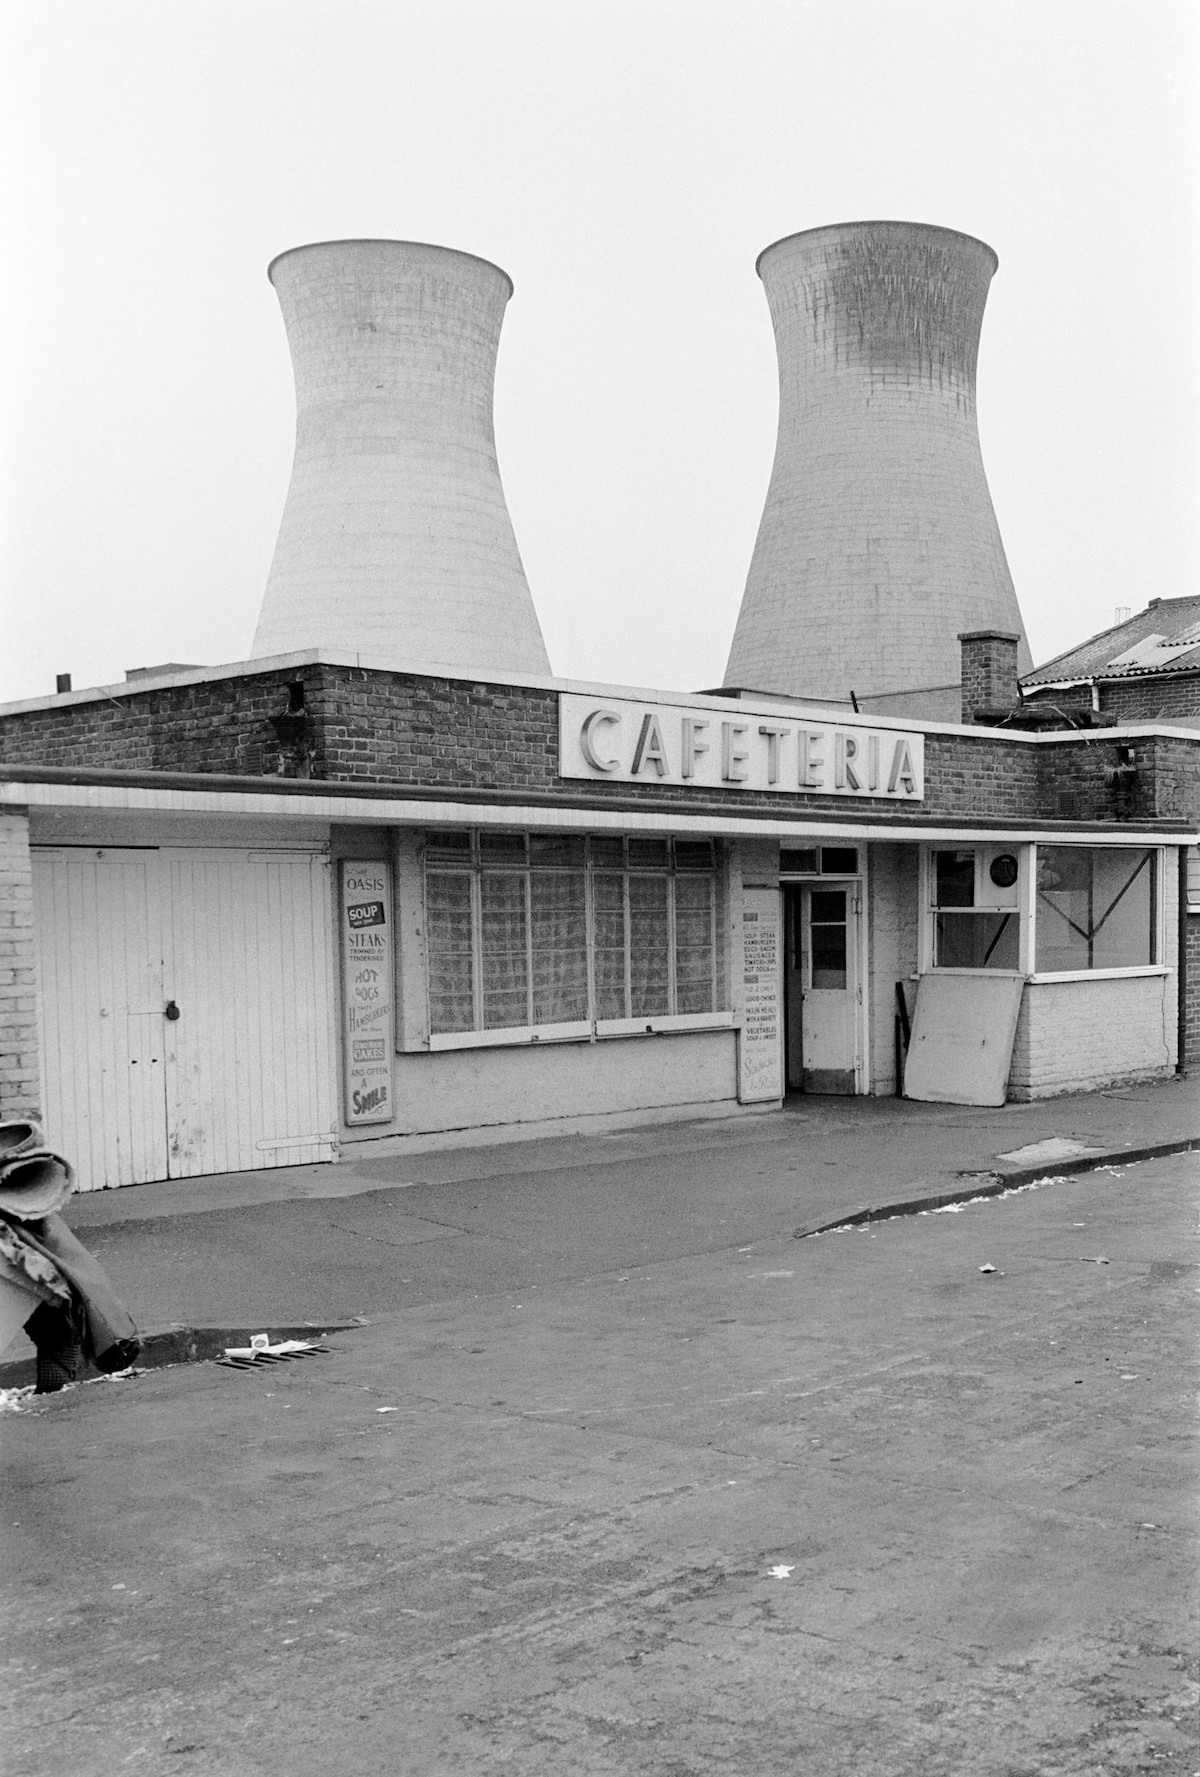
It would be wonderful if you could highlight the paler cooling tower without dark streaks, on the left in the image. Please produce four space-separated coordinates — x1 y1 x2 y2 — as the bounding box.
252 240 549 675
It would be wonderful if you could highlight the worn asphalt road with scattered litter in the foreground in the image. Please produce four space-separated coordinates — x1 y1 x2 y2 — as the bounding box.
0 1155 1200 1777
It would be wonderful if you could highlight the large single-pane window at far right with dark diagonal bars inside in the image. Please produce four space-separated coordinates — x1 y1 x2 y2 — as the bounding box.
1035 846 1157 974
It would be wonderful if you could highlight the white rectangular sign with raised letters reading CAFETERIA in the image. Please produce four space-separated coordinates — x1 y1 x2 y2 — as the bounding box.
558 691 924 801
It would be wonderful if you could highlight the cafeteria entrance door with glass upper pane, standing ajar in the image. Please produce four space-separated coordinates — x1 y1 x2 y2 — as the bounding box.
788 883 859 1093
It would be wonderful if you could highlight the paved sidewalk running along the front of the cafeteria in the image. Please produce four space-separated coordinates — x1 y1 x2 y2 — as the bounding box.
0 1079 1200 1386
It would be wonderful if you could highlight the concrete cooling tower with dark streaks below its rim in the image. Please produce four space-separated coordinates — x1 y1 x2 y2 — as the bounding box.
725 222 1033 721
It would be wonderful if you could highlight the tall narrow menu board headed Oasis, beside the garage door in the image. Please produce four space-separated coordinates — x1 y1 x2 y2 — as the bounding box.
341 858 395 1123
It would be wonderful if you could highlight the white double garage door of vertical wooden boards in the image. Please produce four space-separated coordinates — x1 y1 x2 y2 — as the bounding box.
34 848 338 1191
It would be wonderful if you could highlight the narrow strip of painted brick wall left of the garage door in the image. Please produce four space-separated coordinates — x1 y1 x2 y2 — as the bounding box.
0 809 41 1120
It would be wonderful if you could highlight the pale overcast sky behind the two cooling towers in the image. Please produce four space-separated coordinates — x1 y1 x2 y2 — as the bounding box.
0 0 1200 702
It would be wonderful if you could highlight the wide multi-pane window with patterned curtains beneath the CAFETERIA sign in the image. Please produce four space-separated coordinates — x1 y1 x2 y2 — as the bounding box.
425 832 727 1036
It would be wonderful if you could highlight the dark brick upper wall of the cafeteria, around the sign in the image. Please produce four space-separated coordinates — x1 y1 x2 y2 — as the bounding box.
0 665 1200 835
